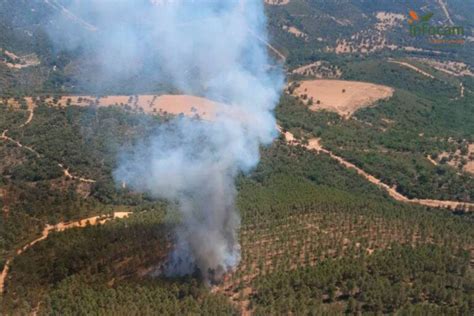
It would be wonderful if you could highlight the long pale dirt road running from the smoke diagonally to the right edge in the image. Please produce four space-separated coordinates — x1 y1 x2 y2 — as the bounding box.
278 127 474 211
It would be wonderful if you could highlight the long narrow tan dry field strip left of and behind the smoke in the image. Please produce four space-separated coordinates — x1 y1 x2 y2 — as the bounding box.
7 95 219 119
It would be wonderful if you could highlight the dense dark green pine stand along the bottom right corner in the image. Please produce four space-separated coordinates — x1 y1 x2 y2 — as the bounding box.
252 244 474 315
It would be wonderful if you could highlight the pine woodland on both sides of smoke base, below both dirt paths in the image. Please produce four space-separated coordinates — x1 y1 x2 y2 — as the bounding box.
3 124 474 314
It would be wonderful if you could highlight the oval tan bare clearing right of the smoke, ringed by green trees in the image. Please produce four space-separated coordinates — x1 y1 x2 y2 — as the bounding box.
290 80 394 118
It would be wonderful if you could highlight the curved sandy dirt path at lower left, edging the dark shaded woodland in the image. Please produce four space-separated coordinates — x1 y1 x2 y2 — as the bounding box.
0 212 132 294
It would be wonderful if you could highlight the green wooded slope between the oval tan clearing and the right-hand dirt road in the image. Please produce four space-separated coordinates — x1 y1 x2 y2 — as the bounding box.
277 59 474 201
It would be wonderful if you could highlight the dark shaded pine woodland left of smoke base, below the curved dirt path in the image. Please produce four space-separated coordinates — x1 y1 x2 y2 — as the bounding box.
3 207 235 315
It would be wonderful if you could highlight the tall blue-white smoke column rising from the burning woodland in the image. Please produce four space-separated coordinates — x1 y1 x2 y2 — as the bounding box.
51 0 282 279
